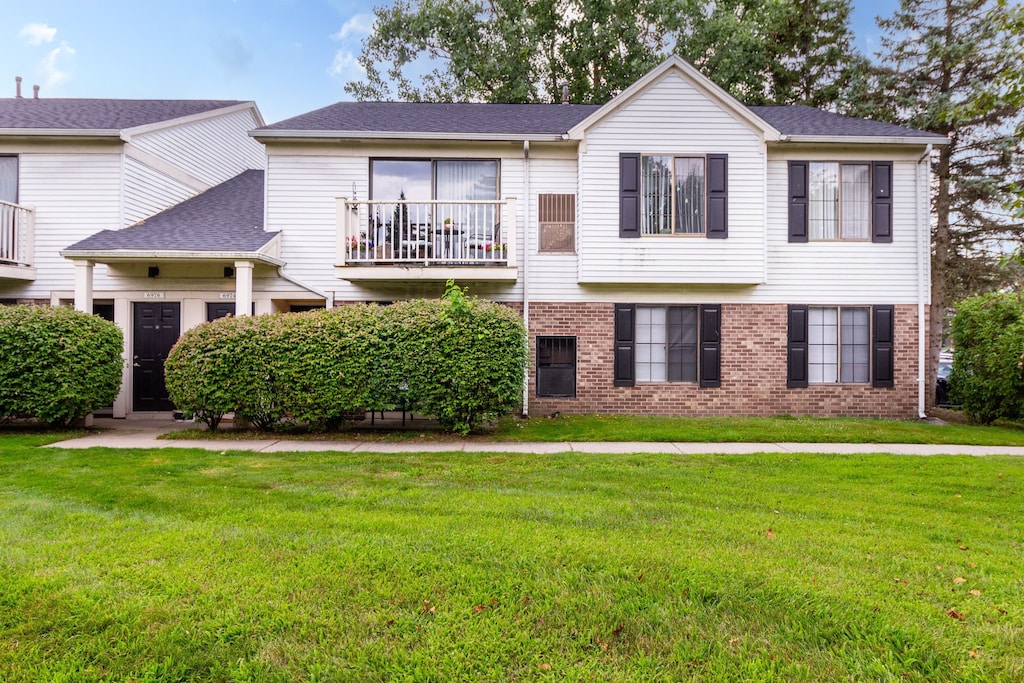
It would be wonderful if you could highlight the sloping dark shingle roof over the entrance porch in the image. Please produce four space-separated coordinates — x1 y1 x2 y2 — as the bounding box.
66 171 276 252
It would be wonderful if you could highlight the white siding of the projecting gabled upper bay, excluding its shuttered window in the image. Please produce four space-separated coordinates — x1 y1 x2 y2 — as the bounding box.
578 73 765 286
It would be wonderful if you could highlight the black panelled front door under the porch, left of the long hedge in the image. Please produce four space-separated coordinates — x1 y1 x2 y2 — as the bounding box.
132 303 181 411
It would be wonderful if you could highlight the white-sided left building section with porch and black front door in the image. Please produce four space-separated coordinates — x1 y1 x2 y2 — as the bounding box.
0 92 276 417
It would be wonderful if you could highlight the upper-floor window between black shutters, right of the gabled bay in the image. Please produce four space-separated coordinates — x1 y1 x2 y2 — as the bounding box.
807 162 871 240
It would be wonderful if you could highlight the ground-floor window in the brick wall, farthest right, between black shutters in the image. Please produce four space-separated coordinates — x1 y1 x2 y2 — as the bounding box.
807 306 871 384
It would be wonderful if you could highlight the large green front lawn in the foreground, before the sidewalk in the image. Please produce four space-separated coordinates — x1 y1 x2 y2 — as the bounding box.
0 435 1024 683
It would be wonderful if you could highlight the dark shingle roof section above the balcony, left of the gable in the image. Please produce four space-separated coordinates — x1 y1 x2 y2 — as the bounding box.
259 102 600 135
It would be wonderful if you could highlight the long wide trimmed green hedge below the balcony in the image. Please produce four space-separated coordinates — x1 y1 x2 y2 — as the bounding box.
165 286 527 434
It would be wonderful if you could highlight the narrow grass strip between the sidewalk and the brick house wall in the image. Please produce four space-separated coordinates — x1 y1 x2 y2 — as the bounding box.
167 415 1024 445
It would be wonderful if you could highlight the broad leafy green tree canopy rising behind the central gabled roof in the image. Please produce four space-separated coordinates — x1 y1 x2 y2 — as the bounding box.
345 0 858 106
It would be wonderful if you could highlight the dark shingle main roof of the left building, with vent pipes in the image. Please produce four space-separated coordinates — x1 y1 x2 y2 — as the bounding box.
0 97 242 130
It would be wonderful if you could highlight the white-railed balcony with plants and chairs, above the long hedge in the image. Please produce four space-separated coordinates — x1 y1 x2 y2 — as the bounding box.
337 198 516 282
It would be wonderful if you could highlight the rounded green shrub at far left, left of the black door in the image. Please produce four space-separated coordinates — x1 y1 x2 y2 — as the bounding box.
0 306 124 426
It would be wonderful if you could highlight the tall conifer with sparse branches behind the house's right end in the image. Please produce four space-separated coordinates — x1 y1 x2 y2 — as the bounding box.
846 0 1024 378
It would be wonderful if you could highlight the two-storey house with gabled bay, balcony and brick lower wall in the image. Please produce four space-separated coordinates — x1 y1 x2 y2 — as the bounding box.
9 57 946 418
